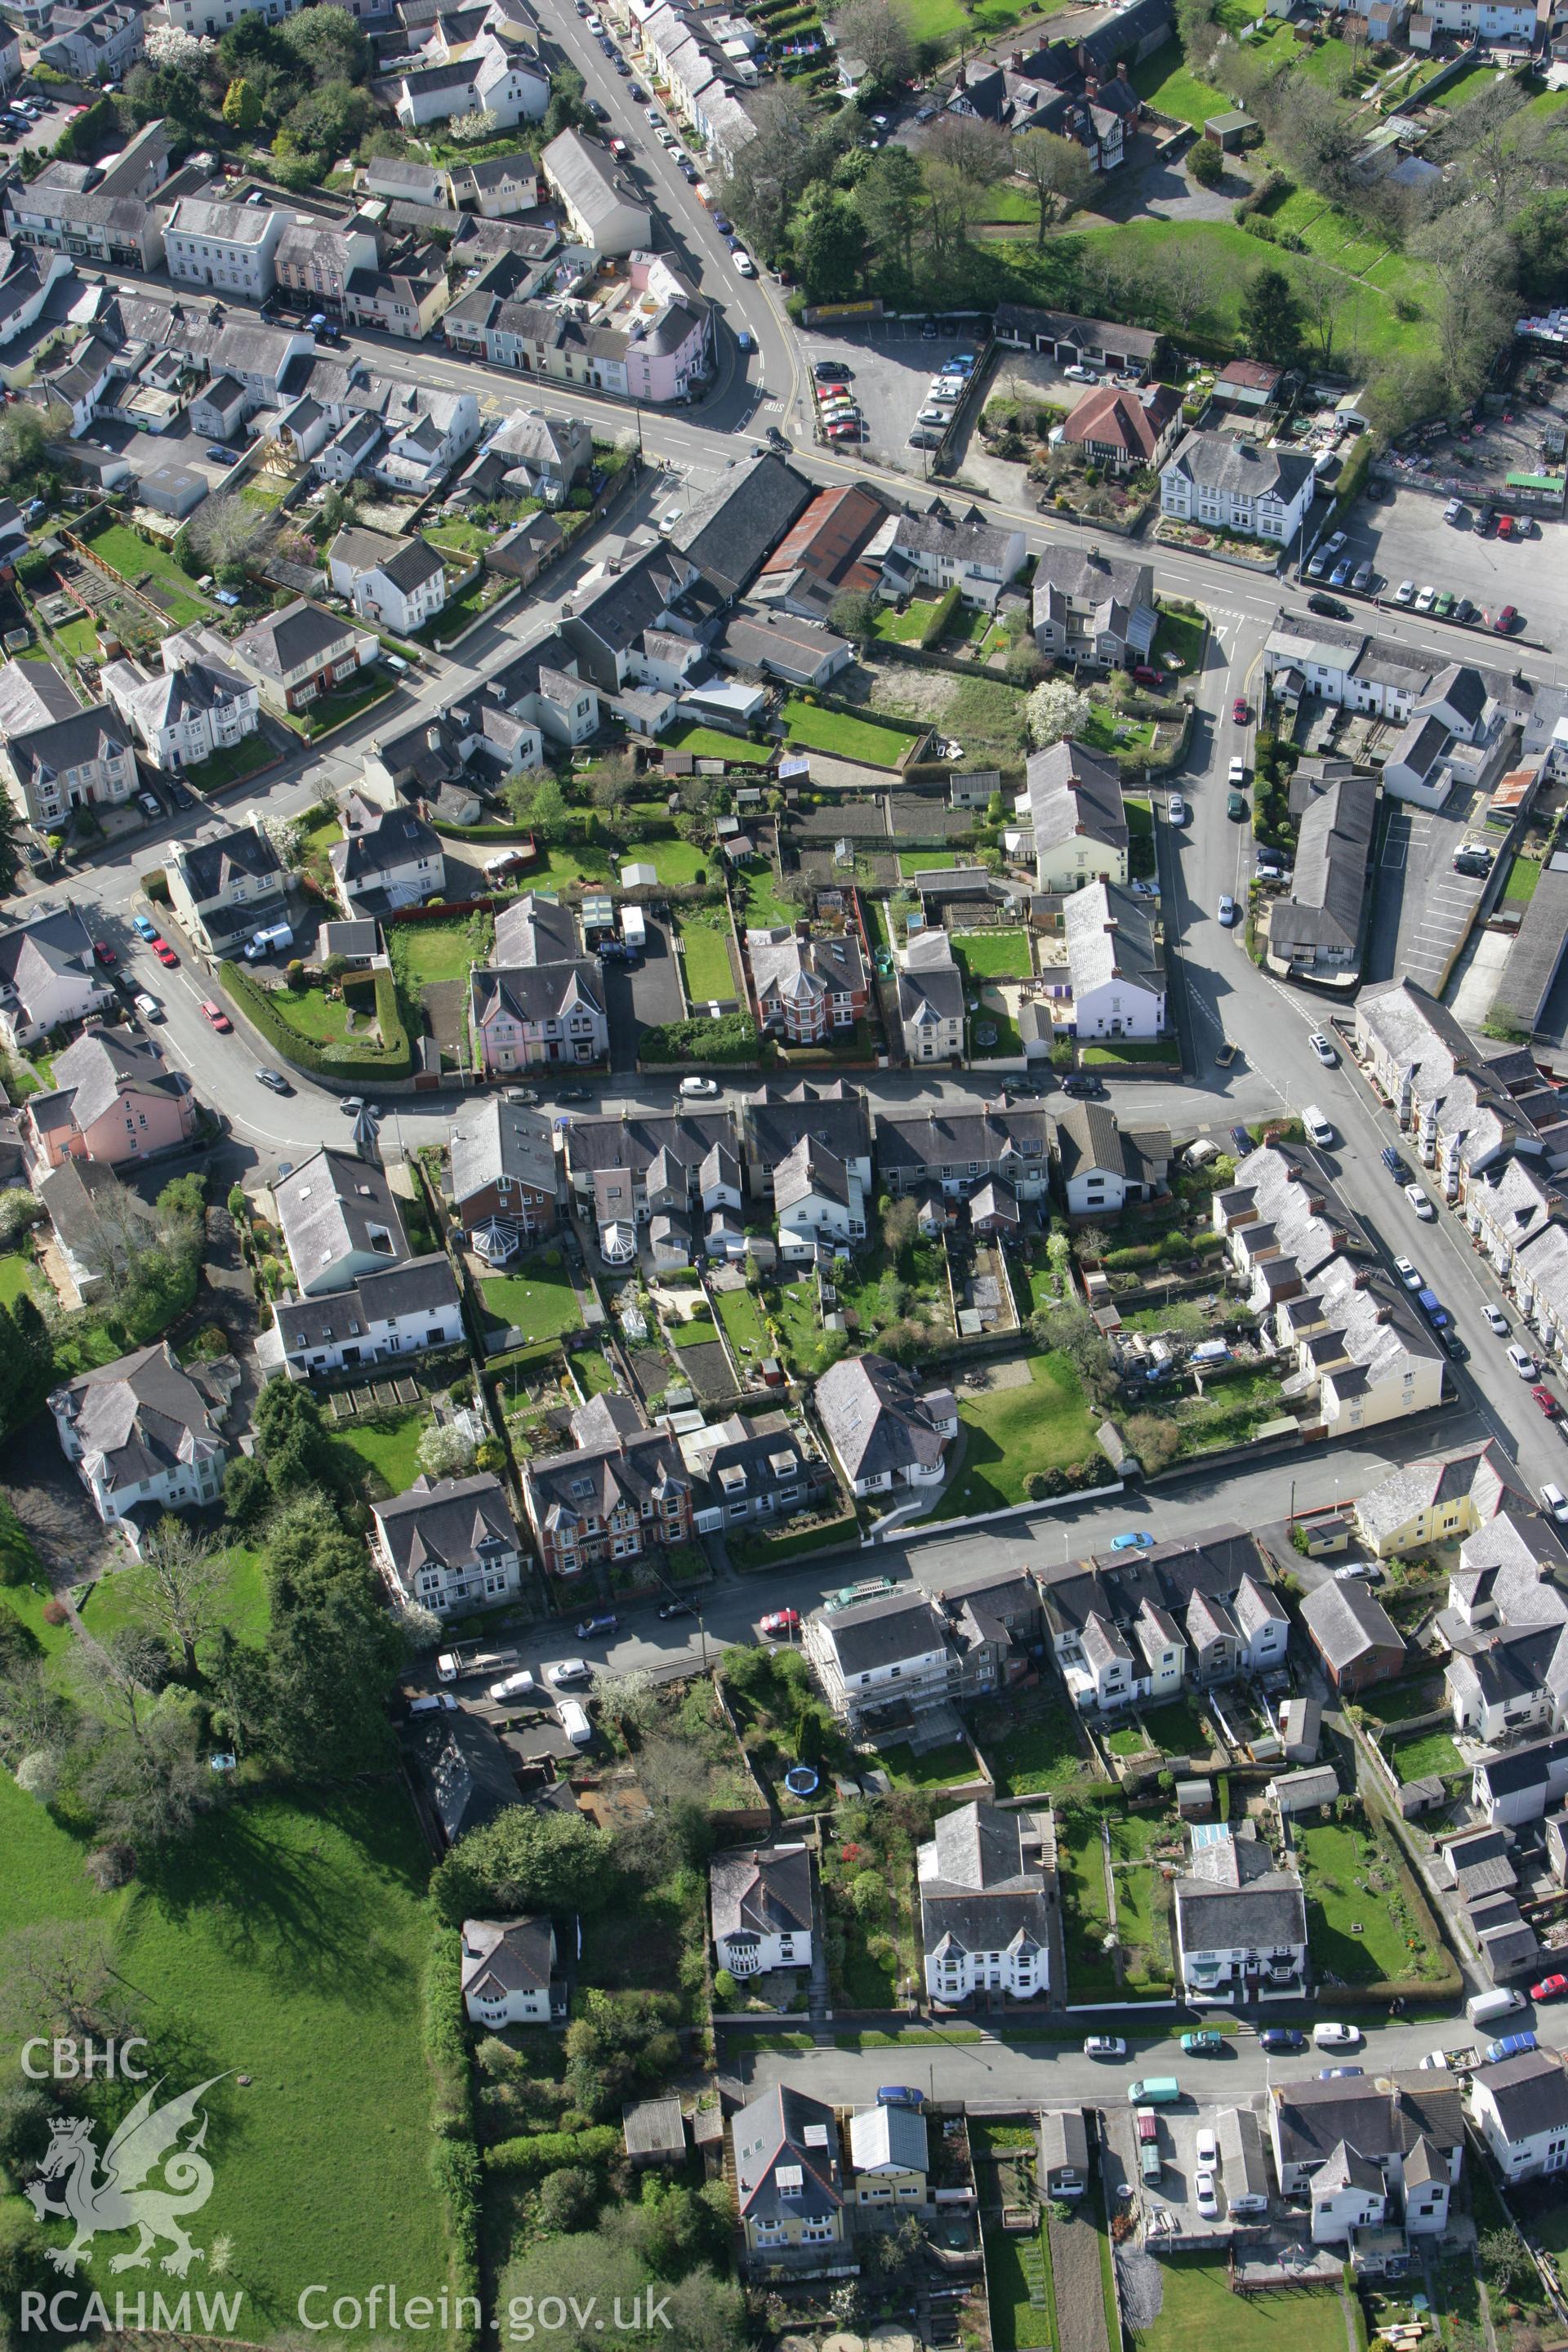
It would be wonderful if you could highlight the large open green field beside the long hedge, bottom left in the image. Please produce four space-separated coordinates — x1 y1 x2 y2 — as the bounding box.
0 1775 447 2342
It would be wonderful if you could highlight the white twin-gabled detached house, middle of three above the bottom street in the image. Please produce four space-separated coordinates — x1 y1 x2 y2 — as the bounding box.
917 1804 1055 2009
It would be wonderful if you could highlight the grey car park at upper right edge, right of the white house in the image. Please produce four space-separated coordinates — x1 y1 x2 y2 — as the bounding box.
1335 489 1568 661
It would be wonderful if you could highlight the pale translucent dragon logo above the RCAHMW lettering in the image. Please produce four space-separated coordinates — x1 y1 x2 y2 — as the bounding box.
26 2074 223 2279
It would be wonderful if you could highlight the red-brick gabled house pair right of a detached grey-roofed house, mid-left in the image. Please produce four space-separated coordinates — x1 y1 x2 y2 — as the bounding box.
522 1430 691 1576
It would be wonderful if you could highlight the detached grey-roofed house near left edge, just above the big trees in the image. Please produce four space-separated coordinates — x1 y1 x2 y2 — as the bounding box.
49 1341 240 1548
